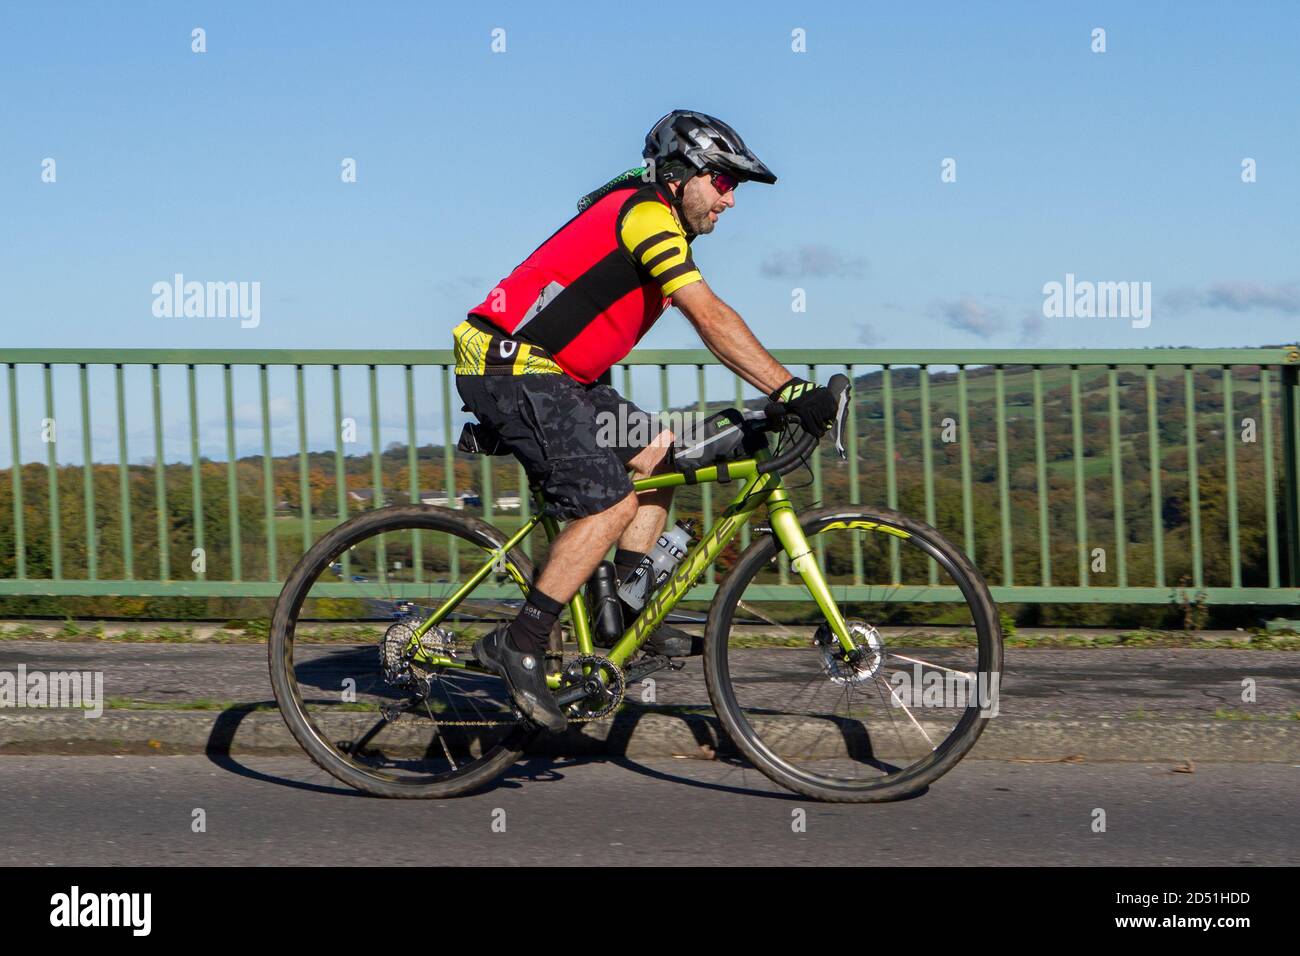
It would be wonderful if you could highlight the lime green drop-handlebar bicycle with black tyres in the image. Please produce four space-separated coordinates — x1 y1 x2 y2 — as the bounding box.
269 375 1002 803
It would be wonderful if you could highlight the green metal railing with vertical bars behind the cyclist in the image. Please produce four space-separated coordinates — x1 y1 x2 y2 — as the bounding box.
0 347 1300 605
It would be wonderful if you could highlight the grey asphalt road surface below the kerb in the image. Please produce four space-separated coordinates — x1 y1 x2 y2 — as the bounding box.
0 757 1300 866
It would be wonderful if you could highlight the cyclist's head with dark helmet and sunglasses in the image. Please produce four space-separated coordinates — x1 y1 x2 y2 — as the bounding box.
641 109 776 235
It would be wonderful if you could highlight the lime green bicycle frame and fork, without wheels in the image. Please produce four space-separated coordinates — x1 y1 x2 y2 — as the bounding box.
408 451 855 687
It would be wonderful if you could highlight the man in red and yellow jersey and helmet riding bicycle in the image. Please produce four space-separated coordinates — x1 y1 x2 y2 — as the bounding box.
452 109 836 731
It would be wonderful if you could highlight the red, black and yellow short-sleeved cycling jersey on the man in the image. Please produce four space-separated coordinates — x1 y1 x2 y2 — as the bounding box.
455 178 701 382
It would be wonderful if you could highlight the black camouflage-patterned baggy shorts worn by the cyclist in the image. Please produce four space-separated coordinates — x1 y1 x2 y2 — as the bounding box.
456 375 659 522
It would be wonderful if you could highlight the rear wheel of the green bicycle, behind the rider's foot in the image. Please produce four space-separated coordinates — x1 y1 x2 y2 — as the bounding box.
269 505 537 797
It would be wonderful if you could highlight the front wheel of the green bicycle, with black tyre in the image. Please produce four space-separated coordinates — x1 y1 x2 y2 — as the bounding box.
705 506 1002 803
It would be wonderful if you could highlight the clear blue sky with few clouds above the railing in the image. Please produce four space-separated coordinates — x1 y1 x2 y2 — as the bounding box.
0 1 1300 463
